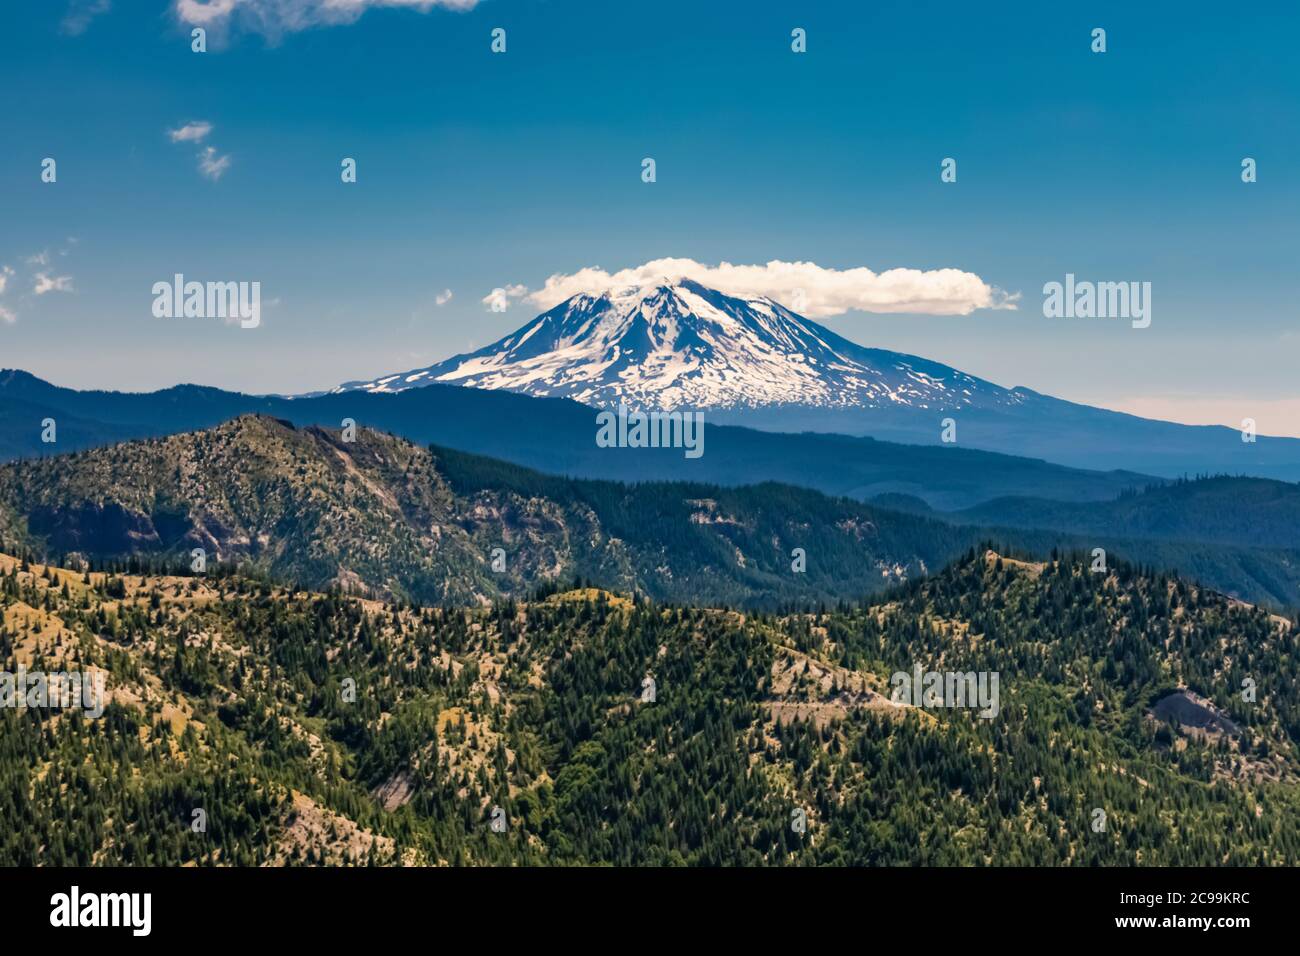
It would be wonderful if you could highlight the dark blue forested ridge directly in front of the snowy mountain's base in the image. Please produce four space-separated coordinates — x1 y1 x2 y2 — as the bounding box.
0 371 1158 510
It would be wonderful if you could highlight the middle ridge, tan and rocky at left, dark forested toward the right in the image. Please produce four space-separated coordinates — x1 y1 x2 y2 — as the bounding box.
0 415 1300 607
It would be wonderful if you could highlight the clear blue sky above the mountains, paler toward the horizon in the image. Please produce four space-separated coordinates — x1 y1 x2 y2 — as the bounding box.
0 0 1300 434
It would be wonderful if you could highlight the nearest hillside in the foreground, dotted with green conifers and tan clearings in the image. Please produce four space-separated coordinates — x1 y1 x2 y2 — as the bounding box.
0 551 1300 865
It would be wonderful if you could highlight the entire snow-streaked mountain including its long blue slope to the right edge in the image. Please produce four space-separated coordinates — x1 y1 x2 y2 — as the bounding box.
322 280 1300 481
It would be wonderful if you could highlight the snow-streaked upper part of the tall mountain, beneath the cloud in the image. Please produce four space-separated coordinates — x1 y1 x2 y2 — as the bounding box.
334 280 1034 410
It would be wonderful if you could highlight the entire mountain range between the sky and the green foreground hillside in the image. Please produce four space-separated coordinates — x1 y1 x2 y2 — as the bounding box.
0 282 1300 607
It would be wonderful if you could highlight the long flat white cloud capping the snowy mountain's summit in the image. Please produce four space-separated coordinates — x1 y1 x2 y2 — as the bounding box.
514 259 1019 319
